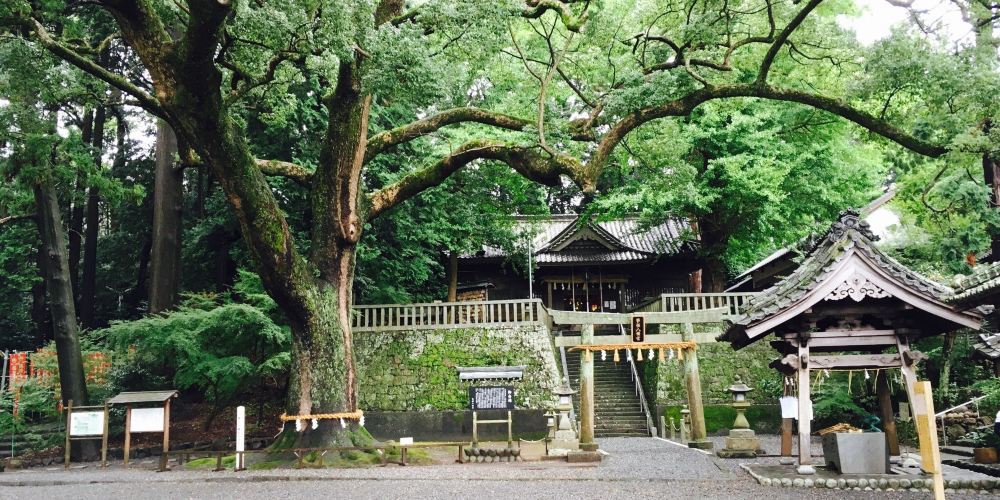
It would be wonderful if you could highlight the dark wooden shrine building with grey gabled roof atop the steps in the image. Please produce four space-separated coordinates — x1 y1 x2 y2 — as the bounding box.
451 214 701 312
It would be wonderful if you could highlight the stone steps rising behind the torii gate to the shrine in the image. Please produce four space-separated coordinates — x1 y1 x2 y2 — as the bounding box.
566 351 649 437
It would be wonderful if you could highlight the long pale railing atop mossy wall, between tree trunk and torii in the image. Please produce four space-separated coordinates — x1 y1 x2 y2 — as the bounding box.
351 299 552 332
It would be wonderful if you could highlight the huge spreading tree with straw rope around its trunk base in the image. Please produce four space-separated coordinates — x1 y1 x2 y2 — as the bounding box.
0 0 992 446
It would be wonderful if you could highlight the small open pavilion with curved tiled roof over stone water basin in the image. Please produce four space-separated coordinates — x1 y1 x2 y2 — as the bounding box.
719 210 982 474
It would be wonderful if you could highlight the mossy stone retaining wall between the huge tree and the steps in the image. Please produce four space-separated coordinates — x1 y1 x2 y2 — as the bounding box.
354 326 559 411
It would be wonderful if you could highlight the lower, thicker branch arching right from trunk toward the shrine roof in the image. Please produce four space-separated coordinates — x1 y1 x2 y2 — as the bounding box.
367 141 593 220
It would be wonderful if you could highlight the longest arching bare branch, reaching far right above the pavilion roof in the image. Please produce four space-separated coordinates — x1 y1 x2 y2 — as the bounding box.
587 83 948 178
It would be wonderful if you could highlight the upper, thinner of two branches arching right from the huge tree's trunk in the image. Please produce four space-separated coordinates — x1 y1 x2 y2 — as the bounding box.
365 108 531 162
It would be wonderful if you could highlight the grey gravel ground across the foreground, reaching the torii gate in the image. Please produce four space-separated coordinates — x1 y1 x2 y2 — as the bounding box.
0 438 985 500
